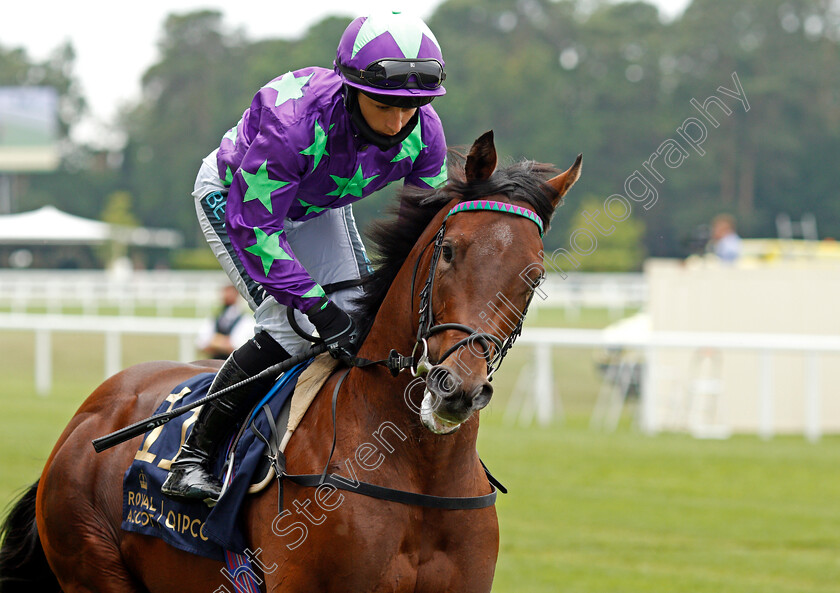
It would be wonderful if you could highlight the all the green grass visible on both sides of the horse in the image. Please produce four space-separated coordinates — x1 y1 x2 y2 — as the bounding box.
0 311 840 593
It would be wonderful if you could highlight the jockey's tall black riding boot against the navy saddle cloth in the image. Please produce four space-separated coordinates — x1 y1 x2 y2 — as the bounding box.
160 333 290 502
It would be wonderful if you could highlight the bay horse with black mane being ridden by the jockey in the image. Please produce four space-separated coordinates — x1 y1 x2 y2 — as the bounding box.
0 132 581 593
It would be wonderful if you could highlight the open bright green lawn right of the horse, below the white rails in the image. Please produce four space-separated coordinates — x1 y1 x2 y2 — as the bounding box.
479 422 840 593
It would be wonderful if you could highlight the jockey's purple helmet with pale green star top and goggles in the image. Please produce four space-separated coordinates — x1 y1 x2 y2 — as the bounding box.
335 12 446 100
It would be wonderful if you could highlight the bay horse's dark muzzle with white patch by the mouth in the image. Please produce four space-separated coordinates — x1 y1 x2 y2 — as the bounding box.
420 365 493 434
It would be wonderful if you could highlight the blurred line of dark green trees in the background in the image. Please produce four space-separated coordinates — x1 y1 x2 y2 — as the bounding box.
0 0 840 269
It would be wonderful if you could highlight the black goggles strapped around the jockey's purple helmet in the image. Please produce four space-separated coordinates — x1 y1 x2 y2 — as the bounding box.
338 58 446 91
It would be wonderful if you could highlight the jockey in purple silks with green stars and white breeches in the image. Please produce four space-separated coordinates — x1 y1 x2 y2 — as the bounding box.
162 12 446 500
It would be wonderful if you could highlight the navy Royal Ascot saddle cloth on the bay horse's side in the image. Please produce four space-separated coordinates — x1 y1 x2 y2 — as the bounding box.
122 360 311 560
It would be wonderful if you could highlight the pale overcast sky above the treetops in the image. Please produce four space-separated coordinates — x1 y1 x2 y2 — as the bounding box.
0 0 689 146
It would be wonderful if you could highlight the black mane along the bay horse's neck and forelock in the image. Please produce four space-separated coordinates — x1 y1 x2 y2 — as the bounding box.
354 150 559 338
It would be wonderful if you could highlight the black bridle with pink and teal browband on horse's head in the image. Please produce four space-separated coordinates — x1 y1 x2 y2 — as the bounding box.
410 200 543 381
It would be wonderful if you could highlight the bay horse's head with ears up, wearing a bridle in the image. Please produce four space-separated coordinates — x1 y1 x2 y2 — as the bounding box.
356 132 581 434
